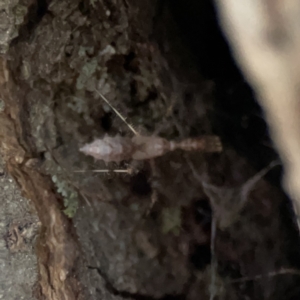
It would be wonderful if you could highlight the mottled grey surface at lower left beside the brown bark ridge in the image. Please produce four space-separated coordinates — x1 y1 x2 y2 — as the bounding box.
0 157 38 300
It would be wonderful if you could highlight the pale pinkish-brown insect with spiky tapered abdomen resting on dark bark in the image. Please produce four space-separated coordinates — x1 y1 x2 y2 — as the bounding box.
80 91 222 162
